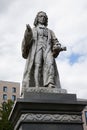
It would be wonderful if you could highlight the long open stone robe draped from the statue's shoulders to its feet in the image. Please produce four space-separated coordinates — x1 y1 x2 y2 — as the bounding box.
22 27 60 91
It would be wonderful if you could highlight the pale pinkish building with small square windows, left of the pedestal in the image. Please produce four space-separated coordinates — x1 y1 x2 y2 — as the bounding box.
0 81 20 104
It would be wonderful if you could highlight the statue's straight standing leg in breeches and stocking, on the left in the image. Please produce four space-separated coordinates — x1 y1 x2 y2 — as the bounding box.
34 49 42 87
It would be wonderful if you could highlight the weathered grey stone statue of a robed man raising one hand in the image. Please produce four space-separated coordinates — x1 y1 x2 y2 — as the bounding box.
22 11 66 94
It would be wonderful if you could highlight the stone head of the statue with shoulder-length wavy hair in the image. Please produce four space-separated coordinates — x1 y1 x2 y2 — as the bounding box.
34 11 48 27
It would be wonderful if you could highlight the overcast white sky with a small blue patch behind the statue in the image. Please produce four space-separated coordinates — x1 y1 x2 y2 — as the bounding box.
0 0 87 99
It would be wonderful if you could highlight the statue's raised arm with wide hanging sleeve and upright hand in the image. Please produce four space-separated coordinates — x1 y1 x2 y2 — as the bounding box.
22 24 33 59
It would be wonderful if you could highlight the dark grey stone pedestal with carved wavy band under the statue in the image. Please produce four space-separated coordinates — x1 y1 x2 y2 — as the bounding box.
9 91 86 130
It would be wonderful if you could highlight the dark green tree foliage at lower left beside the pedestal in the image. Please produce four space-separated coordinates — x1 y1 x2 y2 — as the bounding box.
0 100 14 130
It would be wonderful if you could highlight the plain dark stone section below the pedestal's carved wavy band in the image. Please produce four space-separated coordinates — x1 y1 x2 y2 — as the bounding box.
19 123 83 130
